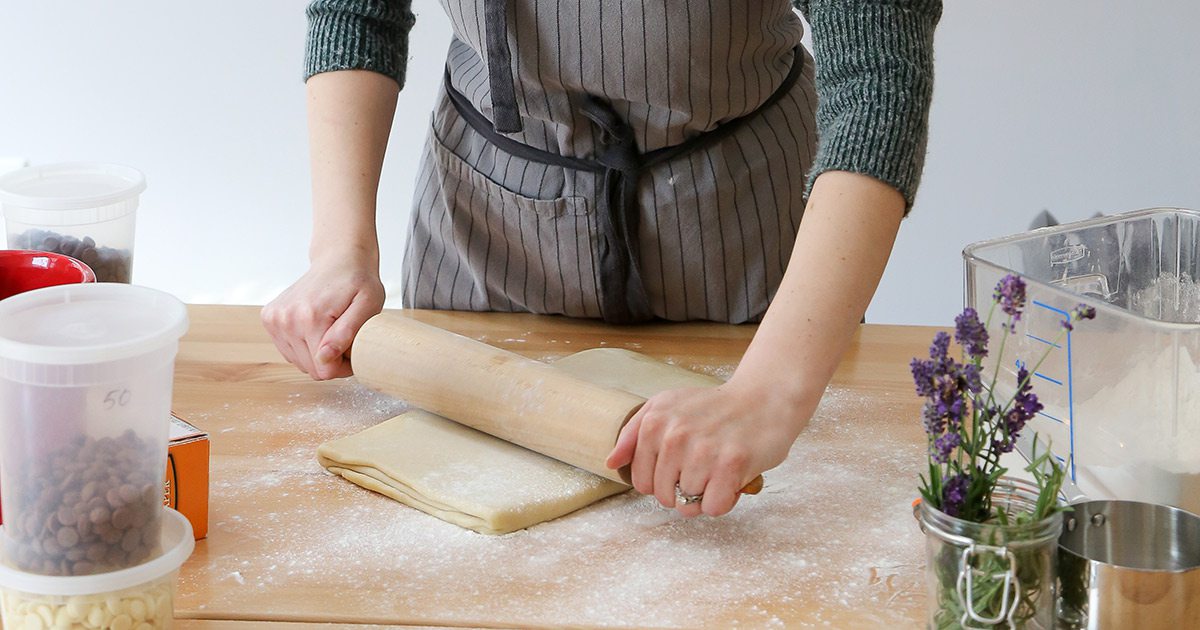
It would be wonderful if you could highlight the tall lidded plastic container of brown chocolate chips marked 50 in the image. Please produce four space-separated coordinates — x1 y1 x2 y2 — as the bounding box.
0 283 187 575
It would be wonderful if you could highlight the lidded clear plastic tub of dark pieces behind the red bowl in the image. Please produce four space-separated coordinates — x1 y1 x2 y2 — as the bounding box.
0 162 146 283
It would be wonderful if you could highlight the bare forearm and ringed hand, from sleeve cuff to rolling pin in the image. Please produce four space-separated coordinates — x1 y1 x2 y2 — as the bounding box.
606 170 905 516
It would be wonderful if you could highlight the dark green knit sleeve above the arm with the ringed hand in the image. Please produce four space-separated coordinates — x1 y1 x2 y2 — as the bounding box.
796 0 942 212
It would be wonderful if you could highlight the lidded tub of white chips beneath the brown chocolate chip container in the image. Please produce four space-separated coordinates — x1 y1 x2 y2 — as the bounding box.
0 508 196 630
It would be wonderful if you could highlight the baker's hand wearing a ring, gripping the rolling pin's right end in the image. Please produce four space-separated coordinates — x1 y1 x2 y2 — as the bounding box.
605 376 815 516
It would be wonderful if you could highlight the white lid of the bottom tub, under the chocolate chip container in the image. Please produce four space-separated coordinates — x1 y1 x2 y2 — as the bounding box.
0 508 196 596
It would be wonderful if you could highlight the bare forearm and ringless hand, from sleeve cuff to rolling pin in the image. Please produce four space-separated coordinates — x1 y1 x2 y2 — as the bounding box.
263 70 400 380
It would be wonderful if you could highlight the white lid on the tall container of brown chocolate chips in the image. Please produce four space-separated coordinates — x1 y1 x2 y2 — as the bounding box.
0 282 187 365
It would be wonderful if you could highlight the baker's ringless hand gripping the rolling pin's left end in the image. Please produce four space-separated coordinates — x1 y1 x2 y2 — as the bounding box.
263 257 384 380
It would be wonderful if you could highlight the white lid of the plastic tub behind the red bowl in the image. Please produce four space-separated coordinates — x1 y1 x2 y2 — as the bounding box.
0 162 146 226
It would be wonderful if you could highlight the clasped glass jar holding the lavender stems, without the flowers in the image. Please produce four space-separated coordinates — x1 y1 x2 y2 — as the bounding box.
918 478 1062 630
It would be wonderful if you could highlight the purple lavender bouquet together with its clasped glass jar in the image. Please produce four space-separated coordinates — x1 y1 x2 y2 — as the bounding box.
911 275 1096 628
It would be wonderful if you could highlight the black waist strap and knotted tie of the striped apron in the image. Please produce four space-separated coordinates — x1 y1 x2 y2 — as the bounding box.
445 47 804 324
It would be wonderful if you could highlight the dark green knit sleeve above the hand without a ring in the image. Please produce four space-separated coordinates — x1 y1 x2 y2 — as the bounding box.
304 0 415 88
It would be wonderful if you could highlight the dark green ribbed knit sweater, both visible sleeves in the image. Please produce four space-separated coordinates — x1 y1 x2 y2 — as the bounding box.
305 0 942 206
